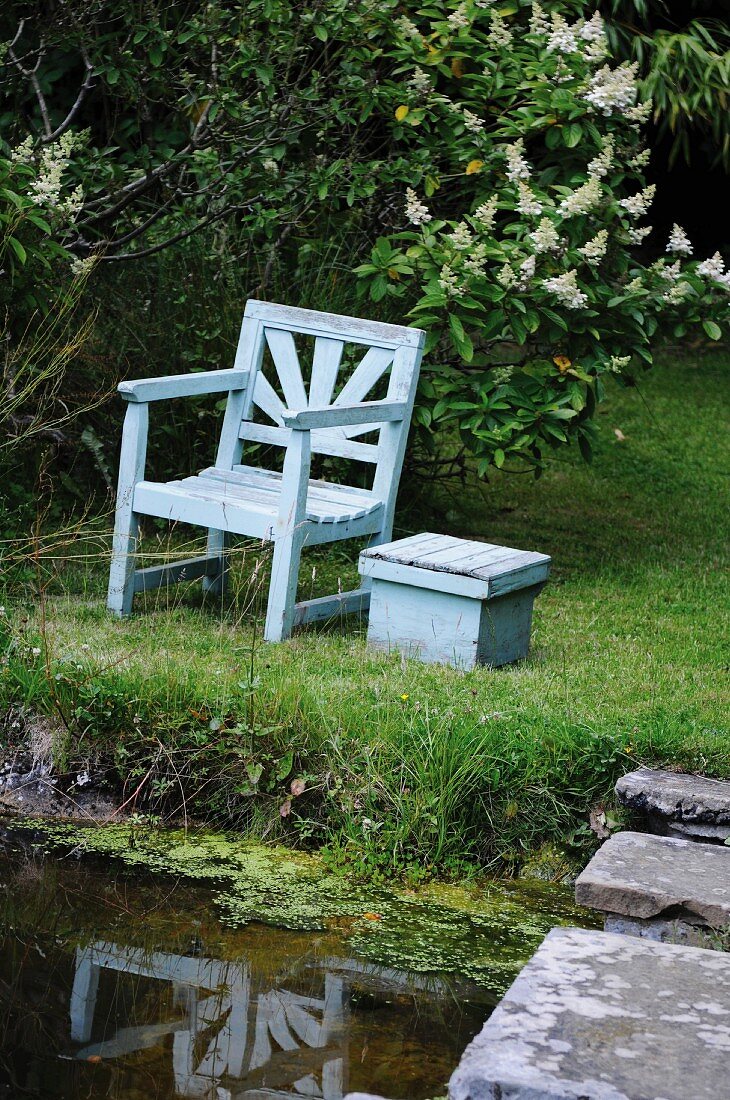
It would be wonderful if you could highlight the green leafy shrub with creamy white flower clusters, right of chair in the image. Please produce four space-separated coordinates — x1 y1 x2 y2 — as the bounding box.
357 0 730 473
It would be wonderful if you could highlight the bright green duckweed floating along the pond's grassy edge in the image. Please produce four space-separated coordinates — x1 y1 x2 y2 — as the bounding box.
5 820 593 993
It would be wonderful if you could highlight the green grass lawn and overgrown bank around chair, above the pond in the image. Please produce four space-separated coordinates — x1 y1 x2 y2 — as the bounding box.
0 353 730 875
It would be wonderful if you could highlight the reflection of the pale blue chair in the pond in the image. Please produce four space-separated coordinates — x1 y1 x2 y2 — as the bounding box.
70 943 347 1100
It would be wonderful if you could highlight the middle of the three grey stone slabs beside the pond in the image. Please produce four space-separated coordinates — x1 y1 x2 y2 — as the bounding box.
575 833 730 928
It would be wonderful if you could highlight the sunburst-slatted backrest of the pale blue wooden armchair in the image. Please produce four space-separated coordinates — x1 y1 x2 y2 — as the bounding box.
217 301 424 496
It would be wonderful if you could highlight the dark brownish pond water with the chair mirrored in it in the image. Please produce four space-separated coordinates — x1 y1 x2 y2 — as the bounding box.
0 831 593 1100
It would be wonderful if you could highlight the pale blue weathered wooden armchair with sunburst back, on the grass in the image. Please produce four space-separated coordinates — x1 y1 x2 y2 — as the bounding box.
108 301 424 641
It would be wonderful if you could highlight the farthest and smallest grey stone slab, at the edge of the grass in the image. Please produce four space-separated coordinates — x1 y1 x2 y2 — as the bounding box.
616 768 730 844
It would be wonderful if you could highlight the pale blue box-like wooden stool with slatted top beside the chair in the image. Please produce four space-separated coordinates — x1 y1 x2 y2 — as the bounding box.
358 532 550 669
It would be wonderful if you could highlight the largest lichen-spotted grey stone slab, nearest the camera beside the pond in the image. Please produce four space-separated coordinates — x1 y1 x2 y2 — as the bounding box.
449 928 730 1100
